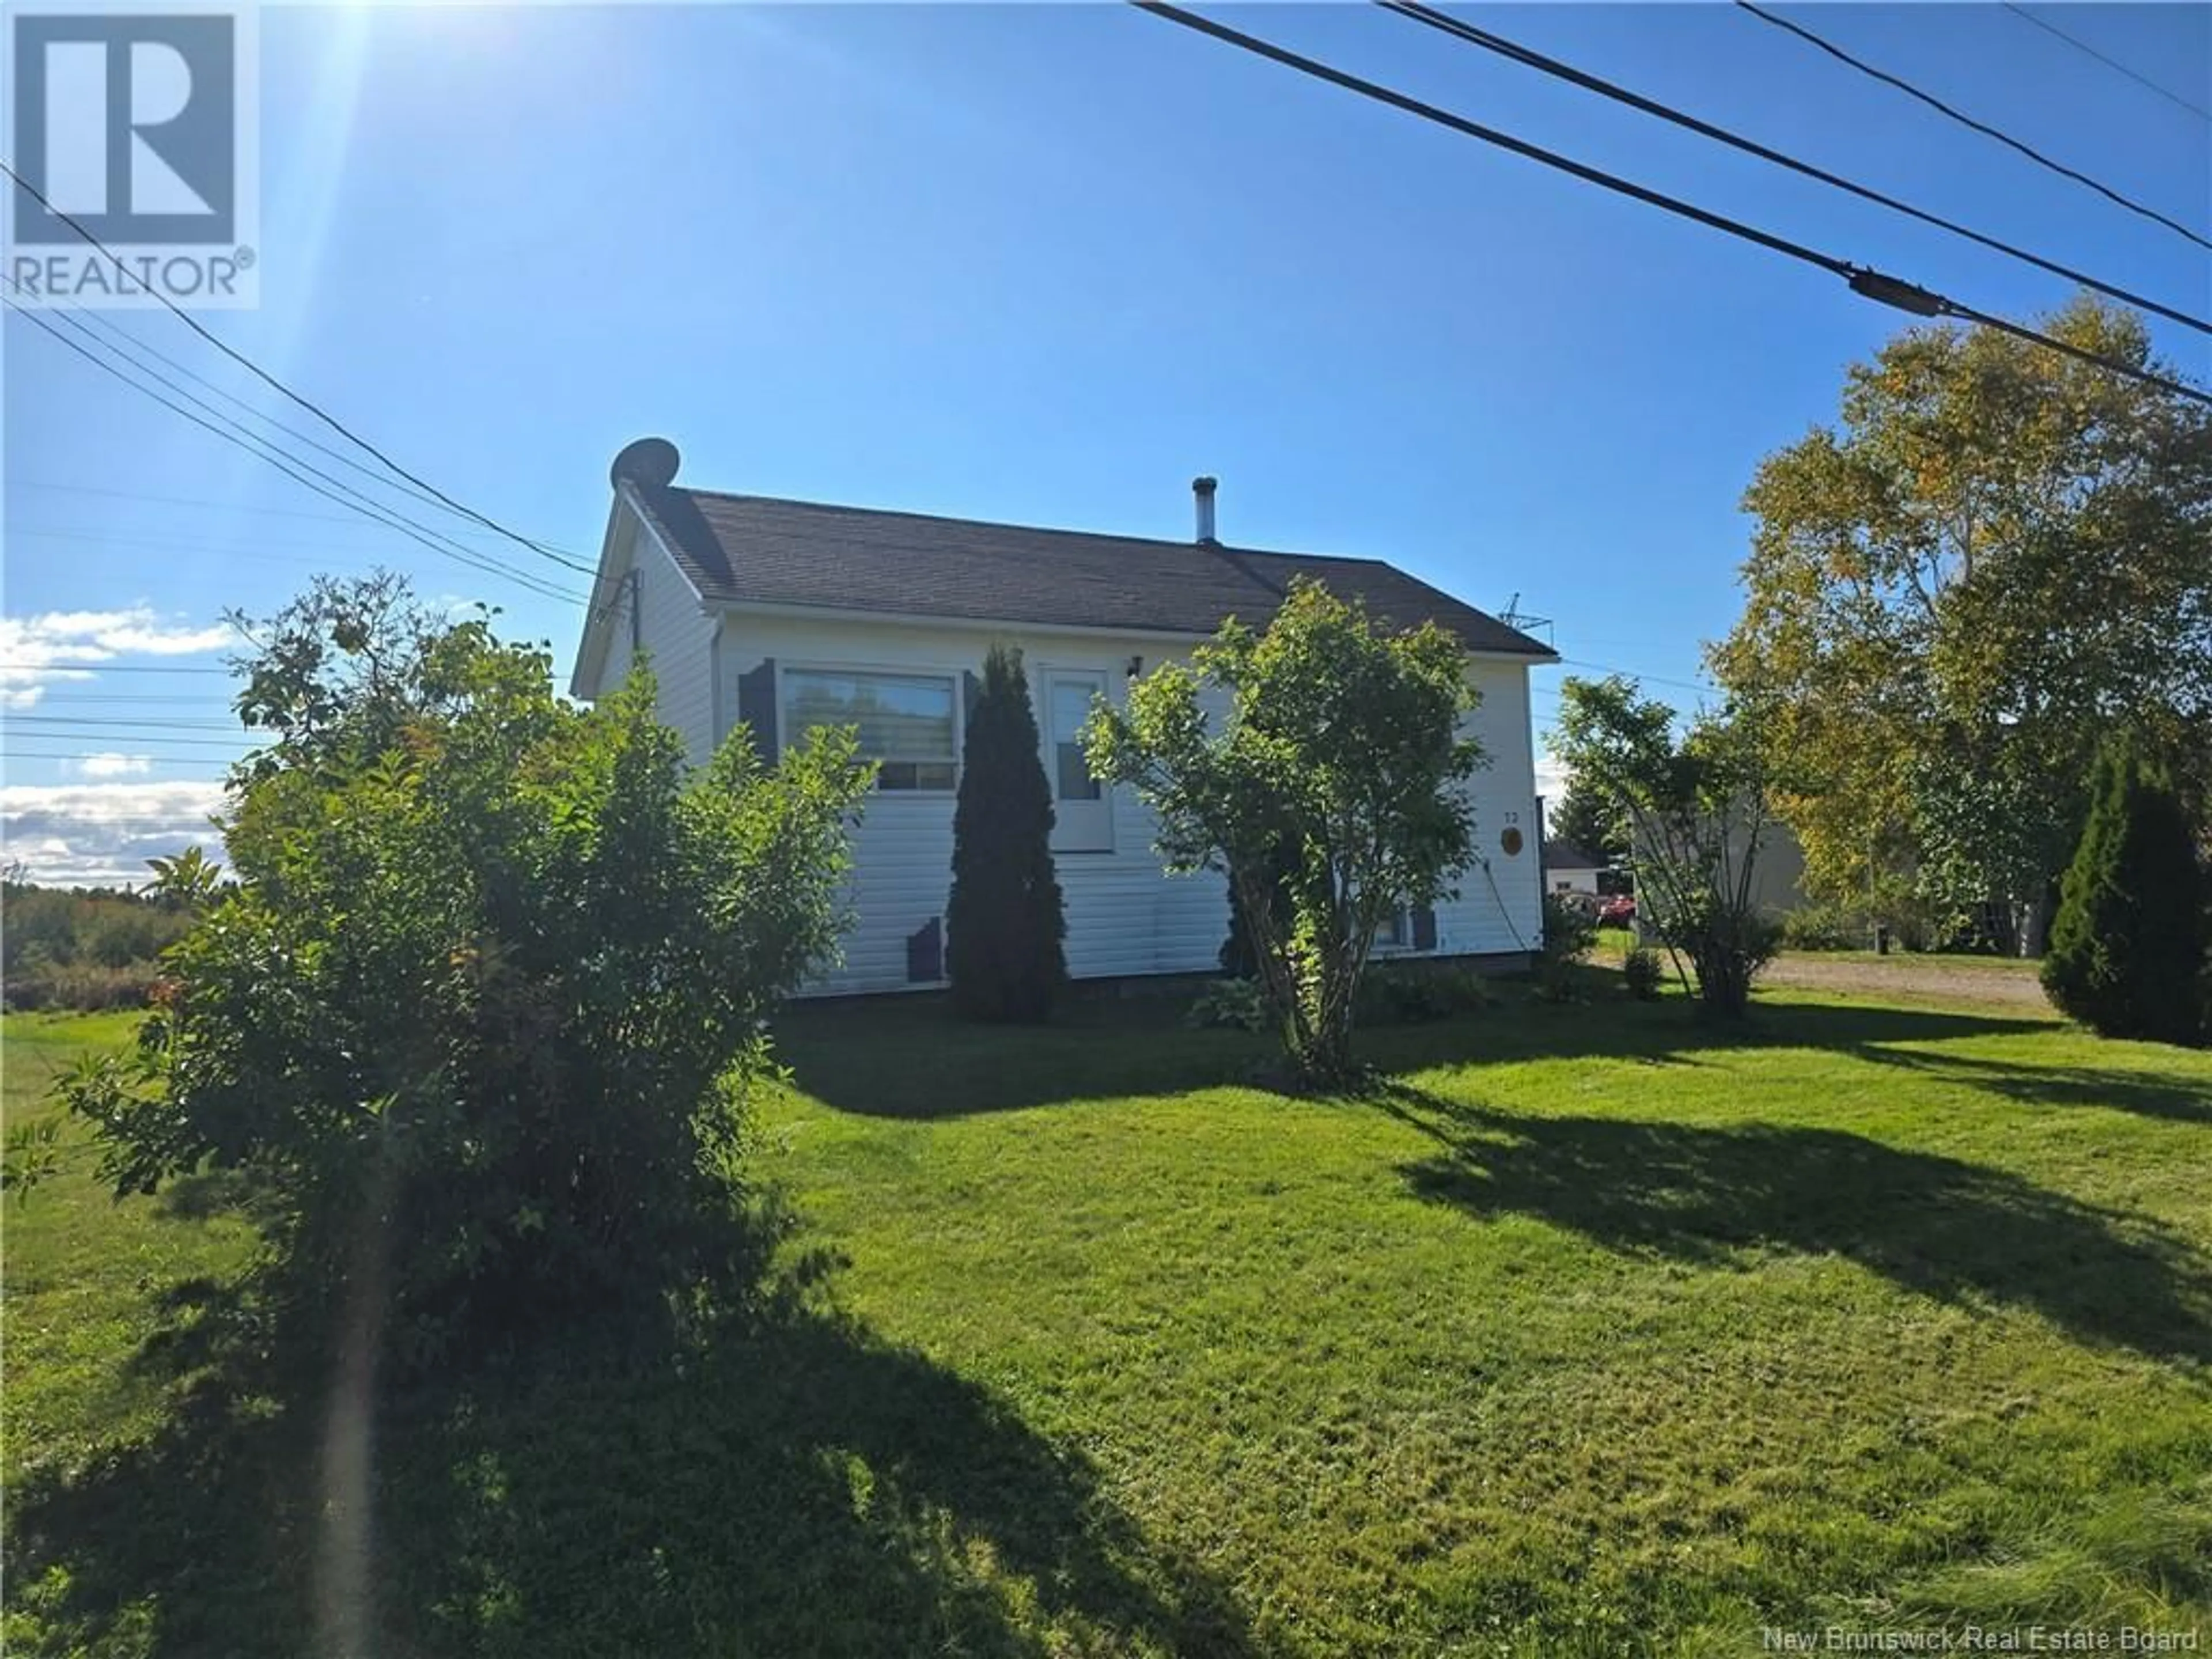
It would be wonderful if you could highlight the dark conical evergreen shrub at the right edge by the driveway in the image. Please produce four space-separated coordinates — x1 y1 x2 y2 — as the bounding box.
2041 739 2205 1042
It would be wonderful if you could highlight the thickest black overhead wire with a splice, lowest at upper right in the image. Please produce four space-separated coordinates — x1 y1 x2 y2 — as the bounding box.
1130 0 2212 407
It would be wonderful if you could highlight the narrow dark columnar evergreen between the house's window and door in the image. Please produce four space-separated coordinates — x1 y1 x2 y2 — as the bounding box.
945 646 1069 1022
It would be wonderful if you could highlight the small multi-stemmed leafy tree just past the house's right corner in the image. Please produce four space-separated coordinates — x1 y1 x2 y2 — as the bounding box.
1551 675 1777 1017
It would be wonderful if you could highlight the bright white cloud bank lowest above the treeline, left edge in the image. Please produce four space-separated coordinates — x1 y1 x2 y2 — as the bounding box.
0 783 224 887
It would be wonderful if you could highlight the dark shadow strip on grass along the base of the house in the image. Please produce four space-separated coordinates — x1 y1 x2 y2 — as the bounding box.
777 984 2051 1119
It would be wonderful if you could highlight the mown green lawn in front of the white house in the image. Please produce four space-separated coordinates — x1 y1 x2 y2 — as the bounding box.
7 991 2212 1659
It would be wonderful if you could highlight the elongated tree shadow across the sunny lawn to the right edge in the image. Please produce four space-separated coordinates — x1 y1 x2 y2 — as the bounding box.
1376 1086 2212 1361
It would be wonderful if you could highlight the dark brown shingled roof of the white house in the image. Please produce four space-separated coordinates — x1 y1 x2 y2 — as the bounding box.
630 480 1553 657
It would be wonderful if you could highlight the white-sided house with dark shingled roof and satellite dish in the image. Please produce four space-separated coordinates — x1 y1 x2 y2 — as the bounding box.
571 438 1555 993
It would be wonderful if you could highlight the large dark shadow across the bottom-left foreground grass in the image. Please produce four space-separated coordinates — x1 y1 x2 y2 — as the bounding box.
9 1298 1254 1659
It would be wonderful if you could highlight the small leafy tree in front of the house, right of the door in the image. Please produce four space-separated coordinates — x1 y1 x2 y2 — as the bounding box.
1086 582 1482 1086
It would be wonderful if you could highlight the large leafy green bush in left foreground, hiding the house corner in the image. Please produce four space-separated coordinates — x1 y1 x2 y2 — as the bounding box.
50 584 869 1365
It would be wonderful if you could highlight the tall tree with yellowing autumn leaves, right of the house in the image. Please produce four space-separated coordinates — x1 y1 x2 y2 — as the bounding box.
1712 298 2212 951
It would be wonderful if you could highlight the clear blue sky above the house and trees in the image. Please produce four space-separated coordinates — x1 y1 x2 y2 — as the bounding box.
0 5 2212 878
